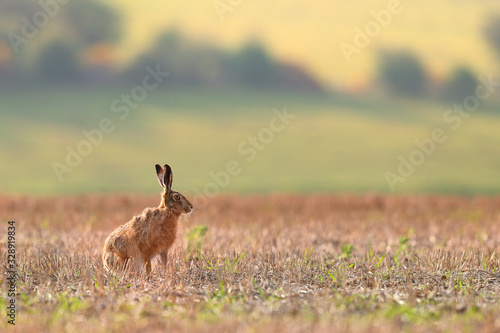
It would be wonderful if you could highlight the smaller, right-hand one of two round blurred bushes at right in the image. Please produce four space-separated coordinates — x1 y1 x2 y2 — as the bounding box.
444 67 478 101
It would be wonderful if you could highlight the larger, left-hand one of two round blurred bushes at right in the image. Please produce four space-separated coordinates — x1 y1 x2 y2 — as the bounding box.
378 51 427 96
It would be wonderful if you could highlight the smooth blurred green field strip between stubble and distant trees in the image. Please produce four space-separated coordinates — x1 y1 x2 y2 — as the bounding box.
0 88 500 194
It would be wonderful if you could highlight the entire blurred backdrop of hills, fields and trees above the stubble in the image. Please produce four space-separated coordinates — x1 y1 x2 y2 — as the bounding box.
0 0 500 196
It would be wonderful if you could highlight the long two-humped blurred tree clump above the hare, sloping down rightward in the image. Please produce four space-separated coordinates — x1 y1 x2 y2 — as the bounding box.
124 30 320 91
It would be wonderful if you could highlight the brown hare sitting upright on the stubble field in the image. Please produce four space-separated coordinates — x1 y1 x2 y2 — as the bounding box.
102 164 193 277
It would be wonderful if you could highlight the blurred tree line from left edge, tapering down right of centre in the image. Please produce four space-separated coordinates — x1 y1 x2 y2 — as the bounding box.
0 0 321 91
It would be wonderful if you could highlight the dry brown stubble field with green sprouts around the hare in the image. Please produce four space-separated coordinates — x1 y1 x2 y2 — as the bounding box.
0 195 500 332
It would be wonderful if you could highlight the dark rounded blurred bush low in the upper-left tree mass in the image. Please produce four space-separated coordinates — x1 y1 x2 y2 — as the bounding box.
38 41 80 83
